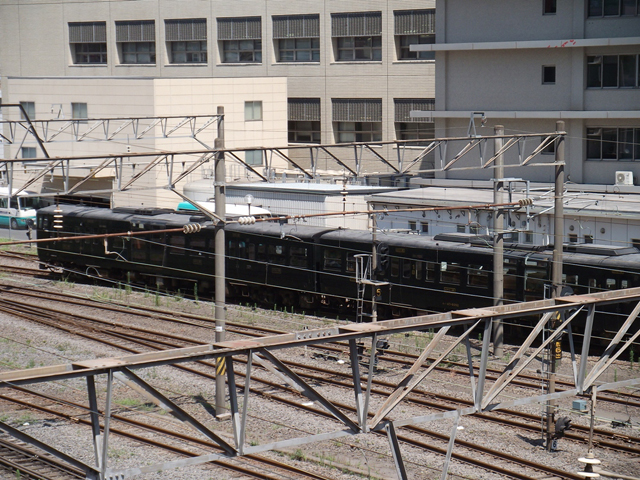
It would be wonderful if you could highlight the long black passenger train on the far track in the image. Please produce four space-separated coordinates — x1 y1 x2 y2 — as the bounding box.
37 205 640 340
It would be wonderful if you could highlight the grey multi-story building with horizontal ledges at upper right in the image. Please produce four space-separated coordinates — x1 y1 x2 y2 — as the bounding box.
426 0 640 185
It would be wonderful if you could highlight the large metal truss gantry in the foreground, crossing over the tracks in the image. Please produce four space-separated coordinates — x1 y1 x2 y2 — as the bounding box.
0 288 640 480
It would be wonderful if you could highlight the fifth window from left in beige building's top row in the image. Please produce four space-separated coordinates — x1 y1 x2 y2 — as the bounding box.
273 15 320 62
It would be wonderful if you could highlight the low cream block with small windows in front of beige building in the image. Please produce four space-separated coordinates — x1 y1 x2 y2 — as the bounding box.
5 77 287 207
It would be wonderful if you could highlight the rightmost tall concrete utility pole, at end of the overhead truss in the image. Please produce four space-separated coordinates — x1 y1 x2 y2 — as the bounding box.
547 121 564 452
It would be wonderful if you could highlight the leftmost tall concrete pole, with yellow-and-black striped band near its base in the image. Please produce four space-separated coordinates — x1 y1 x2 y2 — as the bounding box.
214 107 227 418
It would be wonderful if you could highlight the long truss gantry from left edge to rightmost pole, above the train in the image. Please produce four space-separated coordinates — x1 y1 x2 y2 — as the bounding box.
0 129 565 199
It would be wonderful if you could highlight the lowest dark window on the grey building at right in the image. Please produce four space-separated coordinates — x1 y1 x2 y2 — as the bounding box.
587 127 640 161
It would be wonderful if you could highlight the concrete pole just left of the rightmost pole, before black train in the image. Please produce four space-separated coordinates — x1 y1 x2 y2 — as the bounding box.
493 125 504 357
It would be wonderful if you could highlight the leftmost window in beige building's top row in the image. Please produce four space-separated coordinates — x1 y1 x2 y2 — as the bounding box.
69 22 107 65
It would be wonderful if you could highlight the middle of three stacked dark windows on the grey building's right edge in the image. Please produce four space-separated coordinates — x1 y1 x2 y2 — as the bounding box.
587 55 640 88
